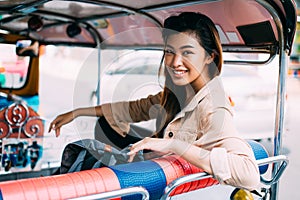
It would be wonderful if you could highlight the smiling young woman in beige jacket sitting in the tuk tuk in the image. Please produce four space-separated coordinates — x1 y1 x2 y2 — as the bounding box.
49 12 260 190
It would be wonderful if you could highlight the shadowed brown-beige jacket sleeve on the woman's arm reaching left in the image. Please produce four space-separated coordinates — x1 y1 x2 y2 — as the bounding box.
101 93 161 137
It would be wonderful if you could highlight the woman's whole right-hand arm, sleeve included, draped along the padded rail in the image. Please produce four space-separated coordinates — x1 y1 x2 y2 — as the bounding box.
129 109 260 190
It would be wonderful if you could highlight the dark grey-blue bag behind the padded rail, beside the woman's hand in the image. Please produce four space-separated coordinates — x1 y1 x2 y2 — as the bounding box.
55 139 144 174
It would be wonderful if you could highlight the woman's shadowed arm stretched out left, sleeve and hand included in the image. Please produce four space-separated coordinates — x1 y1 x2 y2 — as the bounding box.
49 93 160 137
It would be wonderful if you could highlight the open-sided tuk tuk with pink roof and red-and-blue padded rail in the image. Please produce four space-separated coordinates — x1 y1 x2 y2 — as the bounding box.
0 0 297 200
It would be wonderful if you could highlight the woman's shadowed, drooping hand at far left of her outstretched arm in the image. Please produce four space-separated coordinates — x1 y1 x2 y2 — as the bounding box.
48 111 76 137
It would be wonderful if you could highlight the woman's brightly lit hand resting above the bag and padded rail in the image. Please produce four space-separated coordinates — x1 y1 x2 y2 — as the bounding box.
128 137 174 162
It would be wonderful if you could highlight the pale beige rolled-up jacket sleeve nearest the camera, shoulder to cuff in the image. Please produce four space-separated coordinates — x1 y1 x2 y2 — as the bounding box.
195 108 260 190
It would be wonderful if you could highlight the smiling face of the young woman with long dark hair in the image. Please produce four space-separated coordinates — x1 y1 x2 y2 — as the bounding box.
165 33 213 86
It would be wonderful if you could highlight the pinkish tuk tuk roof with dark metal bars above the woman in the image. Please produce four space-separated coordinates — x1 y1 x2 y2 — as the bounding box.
0 0 297 53
